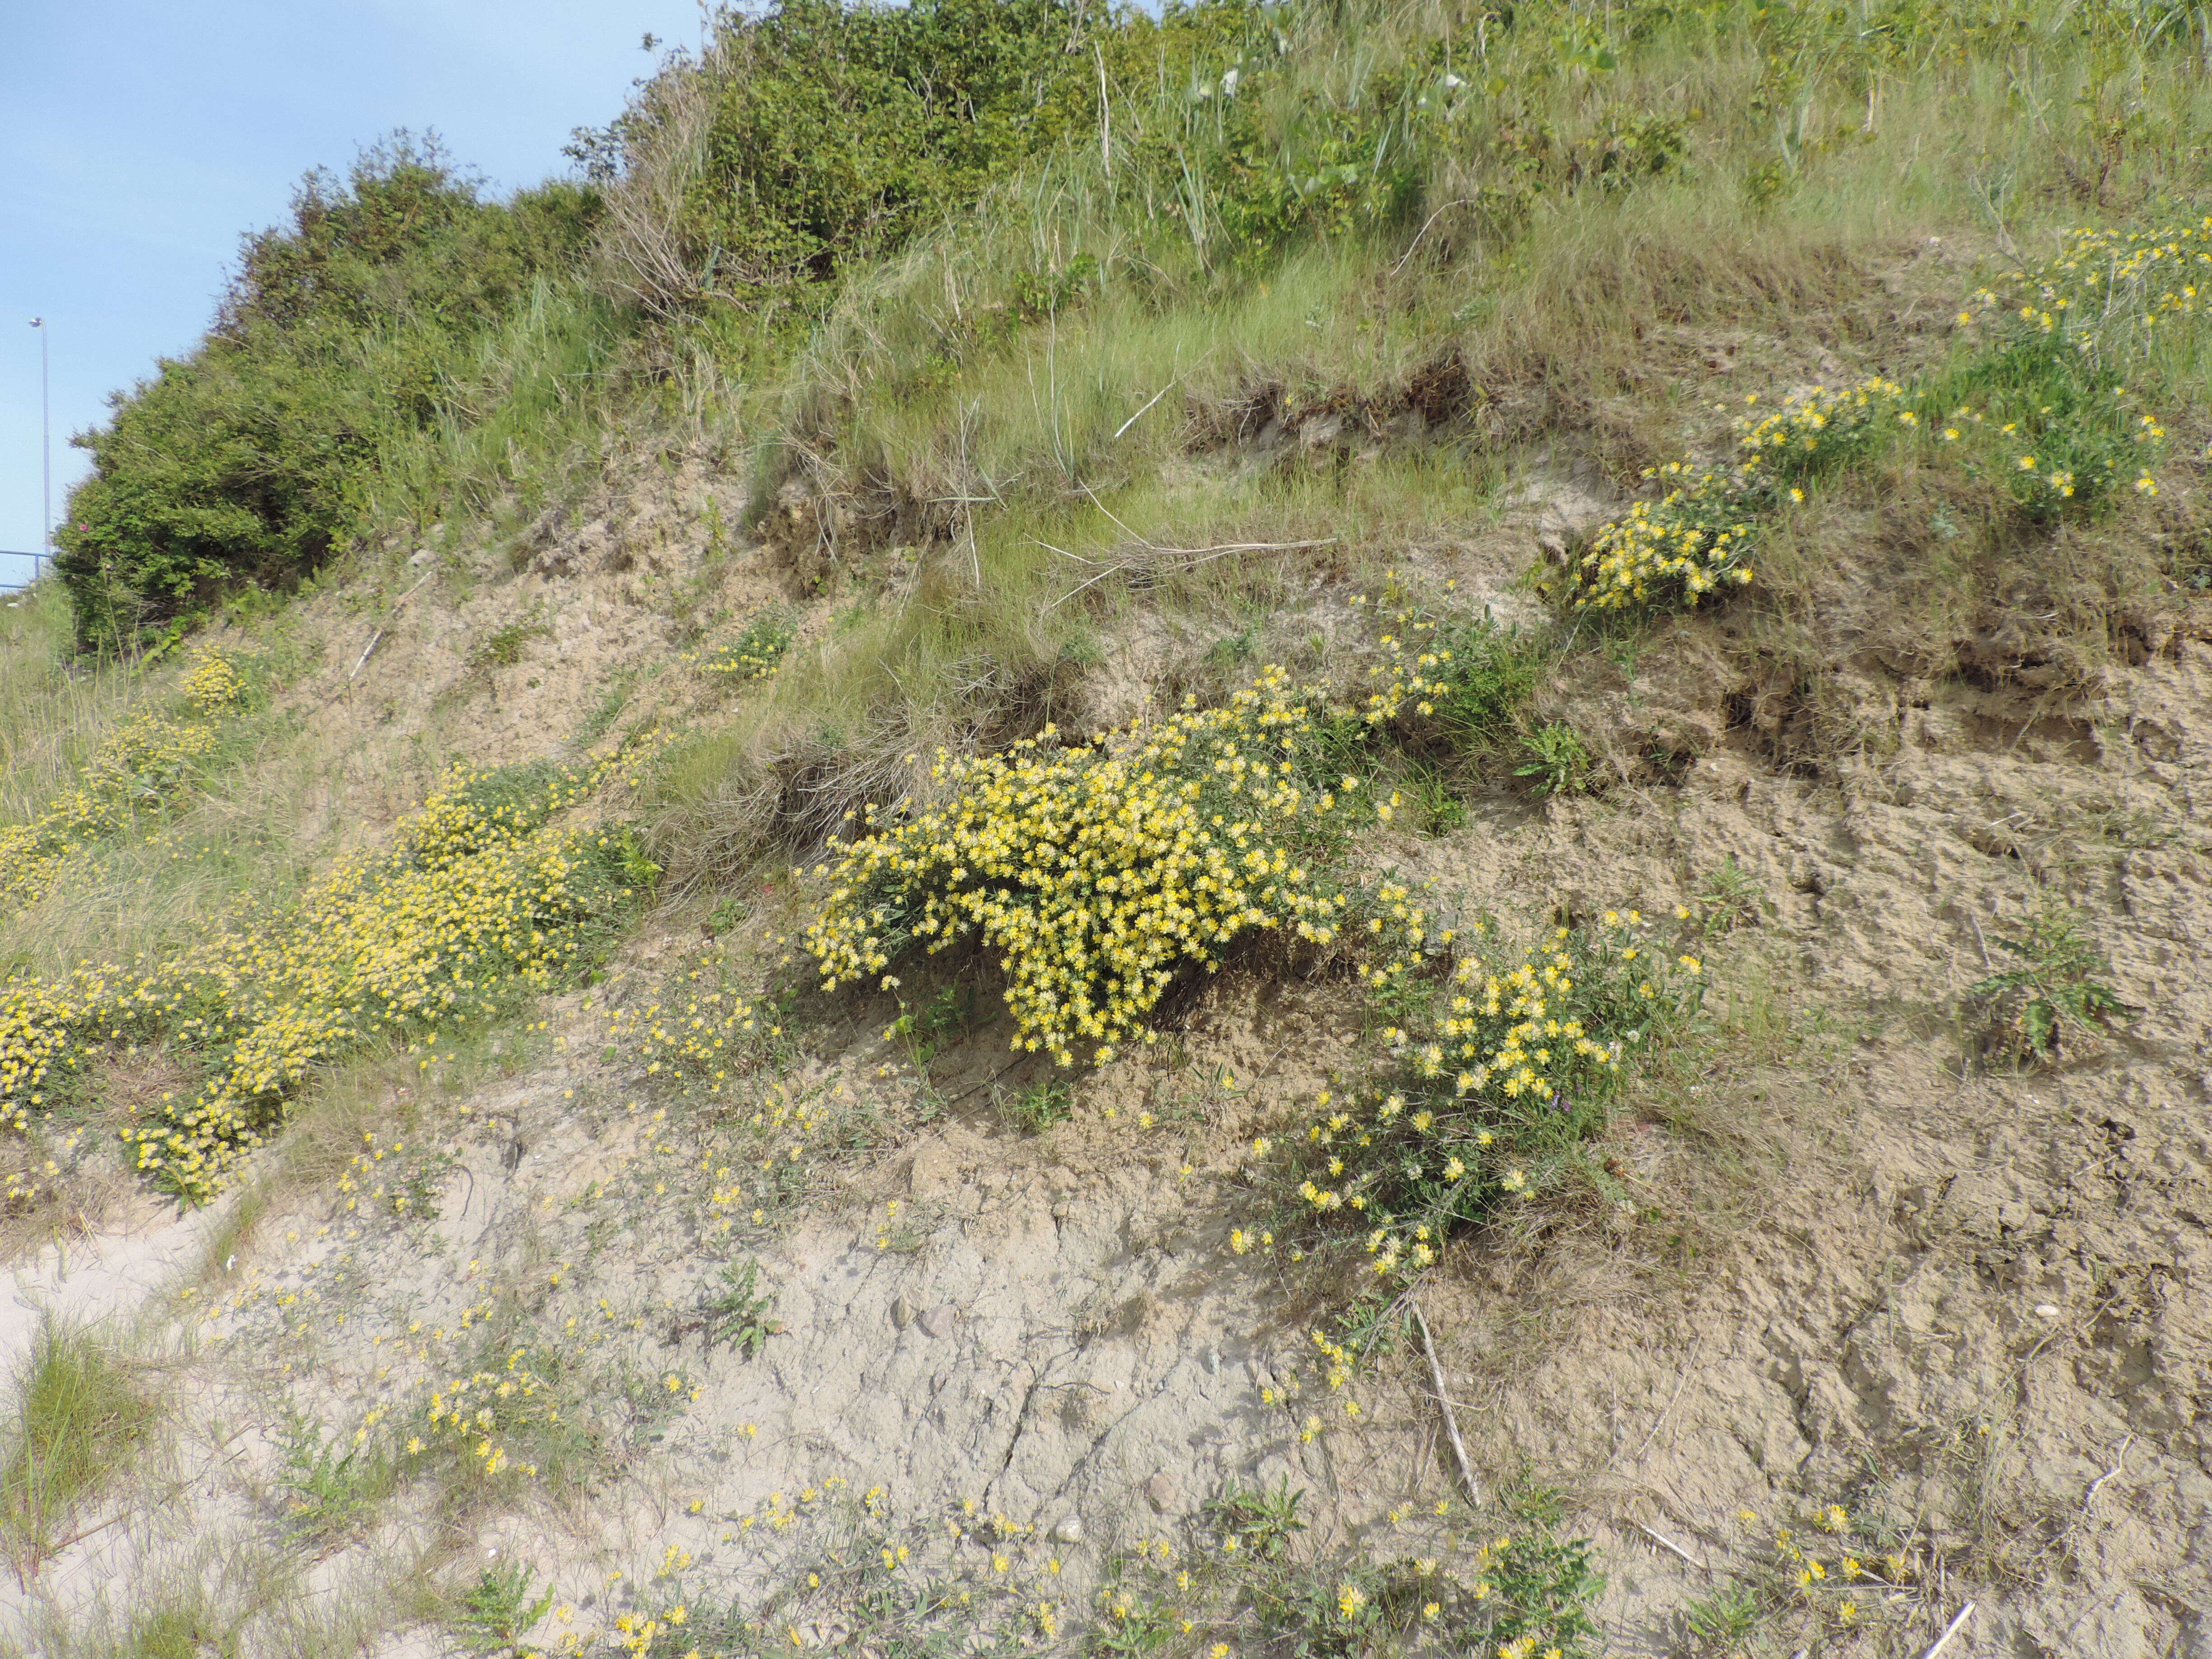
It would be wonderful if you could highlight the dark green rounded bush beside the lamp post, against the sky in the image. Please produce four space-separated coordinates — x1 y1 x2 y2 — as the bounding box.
55 133 597 646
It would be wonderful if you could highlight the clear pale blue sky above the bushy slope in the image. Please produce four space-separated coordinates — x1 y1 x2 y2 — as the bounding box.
0 0 699 584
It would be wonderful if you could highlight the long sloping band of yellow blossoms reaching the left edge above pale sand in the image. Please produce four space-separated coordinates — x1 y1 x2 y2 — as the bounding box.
0 756 626 1199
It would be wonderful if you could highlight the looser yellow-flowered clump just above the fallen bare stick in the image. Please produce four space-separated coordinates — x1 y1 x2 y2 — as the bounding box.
1274 909 1703 1276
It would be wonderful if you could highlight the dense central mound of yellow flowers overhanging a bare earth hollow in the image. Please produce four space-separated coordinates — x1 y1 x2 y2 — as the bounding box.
805 668 1429 1066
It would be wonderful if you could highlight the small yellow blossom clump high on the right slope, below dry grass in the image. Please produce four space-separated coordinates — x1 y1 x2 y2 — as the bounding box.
1564 376 1918 610
